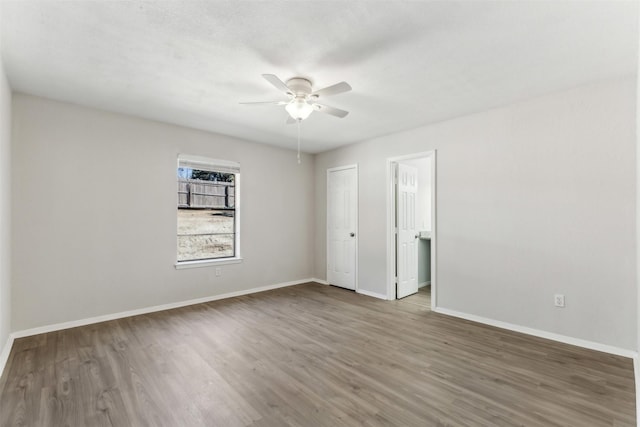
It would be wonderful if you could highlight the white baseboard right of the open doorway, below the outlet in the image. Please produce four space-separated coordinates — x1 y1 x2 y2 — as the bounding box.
433 307 638 360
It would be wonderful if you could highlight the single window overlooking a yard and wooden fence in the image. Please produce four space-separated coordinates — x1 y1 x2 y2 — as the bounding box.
176 155 240 266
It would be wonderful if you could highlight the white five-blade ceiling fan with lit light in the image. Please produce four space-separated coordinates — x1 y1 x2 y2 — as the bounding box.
241 74 351 123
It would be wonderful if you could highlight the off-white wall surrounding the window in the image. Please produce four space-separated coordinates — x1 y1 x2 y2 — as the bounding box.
12 94 315 330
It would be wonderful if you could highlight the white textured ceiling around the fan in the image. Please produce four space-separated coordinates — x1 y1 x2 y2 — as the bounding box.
0 0 638 152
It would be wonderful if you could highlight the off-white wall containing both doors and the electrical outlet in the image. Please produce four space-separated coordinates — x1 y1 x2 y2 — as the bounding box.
315 76 637 350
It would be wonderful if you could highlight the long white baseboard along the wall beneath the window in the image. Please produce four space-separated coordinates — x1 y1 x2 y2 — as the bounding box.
11 279 315 338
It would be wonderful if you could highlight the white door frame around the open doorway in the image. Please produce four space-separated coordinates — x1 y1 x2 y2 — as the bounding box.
386 150 438 310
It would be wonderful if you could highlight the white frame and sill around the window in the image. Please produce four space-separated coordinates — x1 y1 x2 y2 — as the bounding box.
174 154 242 270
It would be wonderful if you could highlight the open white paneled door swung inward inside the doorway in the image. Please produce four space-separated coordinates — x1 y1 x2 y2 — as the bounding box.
396 163 418 298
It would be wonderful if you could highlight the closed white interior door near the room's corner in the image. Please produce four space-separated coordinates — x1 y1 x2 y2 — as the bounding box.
327 166 358 290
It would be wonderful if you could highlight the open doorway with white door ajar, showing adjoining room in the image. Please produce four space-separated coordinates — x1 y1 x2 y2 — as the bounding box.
387 151 437 309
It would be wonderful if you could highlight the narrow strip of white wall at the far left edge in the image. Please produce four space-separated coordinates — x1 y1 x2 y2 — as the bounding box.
0 51 11 354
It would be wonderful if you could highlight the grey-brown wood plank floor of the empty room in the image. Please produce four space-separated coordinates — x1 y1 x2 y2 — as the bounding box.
0 283 635 427
